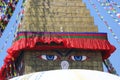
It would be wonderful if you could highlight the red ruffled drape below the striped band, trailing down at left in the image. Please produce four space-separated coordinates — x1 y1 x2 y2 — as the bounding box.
0 32 116 80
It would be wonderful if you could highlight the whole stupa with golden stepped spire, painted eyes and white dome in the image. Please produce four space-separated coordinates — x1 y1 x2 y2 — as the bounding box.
0 0 120 80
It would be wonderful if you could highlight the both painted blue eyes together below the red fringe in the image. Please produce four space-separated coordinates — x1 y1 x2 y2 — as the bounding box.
37 55 88 61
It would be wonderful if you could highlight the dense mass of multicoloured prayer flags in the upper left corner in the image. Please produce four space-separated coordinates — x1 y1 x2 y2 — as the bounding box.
0 0 18 37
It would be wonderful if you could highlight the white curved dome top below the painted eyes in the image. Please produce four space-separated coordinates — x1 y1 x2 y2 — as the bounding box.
10 69 120 80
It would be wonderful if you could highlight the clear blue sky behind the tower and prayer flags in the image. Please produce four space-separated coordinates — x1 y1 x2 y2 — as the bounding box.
0 0 120 75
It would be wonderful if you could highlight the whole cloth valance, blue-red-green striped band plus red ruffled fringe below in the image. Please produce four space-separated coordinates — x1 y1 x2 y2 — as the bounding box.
0 32 115 79
